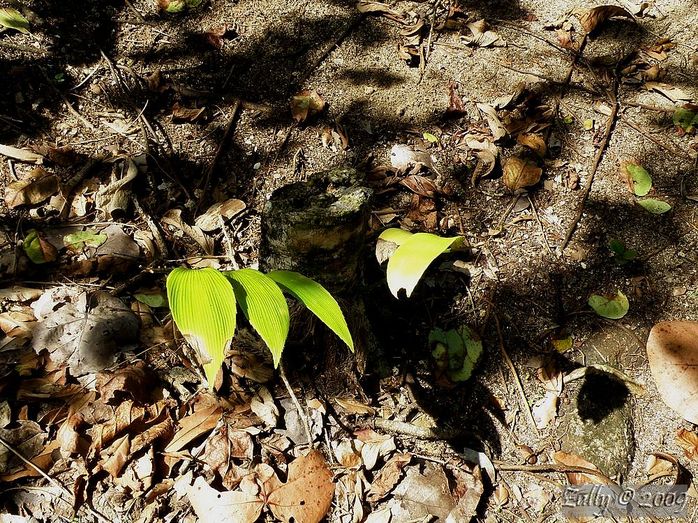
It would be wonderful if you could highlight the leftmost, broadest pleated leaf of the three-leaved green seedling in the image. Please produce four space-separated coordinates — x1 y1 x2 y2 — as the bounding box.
167 267 236 390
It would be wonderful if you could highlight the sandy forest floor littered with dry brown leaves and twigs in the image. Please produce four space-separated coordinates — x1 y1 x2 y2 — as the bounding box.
0 0 698 523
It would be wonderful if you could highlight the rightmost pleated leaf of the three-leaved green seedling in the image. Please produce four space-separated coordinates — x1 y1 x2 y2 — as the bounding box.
267 271 354 352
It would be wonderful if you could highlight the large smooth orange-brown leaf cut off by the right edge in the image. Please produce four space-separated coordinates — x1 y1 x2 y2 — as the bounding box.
647 321 698 423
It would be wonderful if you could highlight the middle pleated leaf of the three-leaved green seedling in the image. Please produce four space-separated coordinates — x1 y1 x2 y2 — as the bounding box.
223 269 291 367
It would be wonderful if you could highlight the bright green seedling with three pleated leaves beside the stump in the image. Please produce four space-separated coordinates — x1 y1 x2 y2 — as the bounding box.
167 267 354 390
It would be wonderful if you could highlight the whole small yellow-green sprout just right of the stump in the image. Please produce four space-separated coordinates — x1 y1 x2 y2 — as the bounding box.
376 229 465 298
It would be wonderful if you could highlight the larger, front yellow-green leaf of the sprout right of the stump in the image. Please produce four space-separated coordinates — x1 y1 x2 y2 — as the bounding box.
387 232 463 298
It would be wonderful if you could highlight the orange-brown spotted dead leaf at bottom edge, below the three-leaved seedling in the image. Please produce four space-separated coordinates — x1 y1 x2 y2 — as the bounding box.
268 450 334 523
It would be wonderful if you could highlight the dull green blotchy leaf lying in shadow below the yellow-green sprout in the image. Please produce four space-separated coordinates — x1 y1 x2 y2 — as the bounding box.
429 325 482 381
